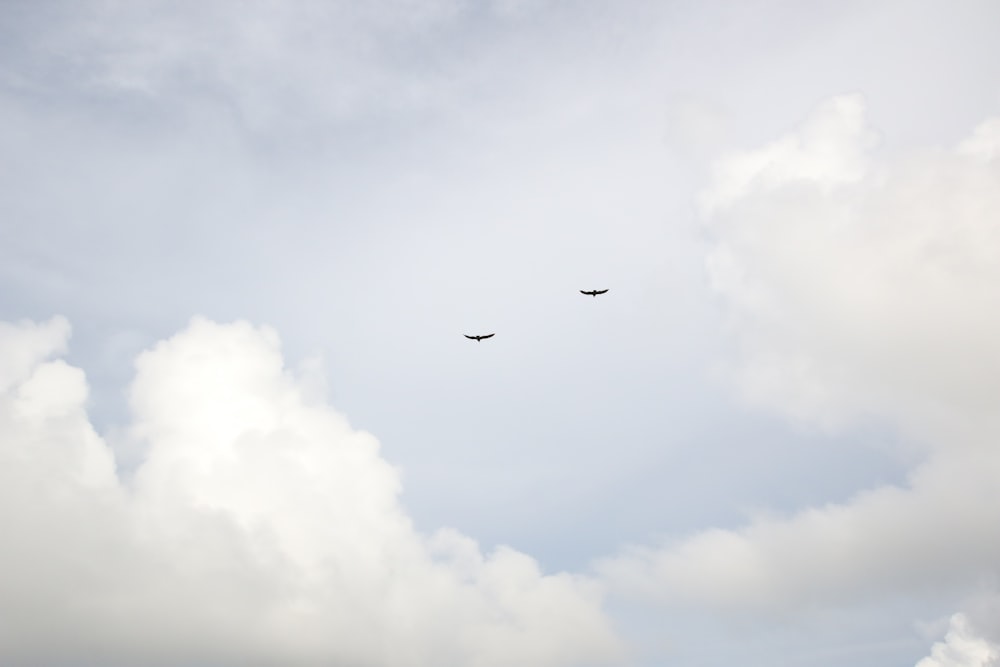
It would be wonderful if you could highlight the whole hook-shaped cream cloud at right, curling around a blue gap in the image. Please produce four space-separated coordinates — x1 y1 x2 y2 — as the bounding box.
600 96 1000 610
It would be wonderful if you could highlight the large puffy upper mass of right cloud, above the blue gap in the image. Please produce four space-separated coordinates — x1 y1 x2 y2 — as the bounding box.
705 97 1000 443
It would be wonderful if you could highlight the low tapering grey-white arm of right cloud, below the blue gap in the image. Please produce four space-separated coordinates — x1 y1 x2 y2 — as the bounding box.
601 446 1000 611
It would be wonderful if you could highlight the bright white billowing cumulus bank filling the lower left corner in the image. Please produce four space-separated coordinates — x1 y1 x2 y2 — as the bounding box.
0 319 620 666
